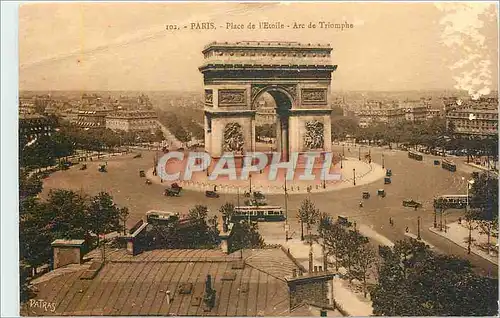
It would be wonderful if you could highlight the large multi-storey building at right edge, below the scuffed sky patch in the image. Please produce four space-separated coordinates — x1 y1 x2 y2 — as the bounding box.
445 98 498 137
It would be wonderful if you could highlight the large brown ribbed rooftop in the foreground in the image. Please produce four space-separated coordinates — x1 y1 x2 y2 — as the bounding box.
27 249 297 316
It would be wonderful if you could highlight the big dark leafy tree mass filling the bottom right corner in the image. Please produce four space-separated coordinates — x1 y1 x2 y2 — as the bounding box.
371 239 498 316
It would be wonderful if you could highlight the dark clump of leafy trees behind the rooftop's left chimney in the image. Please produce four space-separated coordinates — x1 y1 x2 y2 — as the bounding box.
19 189 129 276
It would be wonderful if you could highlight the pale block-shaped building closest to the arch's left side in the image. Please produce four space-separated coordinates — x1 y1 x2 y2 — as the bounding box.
105 110 159 132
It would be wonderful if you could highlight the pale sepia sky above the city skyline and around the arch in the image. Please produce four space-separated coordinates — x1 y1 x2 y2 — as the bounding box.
19 2 498 94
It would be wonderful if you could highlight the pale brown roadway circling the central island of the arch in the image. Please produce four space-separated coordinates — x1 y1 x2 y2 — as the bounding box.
41 145 497 274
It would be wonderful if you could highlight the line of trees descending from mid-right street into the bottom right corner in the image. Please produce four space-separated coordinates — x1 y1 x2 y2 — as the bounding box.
298 199 498 316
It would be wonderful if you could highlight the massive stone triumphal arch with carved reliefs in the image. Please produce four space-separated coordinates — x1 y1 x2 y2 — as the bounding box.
199 42 337 158
